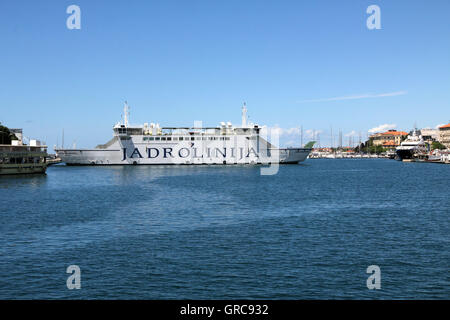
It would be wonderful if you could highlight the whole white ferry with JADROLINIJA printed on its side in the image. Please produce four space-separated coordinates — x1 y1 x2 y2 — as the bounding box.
55 103 314 166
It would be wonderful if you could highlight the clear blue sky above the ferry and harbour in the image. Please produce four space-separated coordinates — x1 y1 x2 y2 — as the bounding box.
0 0 450 147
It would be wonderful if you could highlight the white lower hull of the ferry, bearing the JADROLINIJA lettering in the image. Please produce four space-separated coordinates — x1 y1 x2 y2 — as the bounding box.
55 139 311 165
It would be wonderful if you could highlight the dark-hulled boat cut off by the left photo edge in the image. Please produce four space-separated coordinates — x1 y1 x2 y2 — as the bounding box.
0 129 47 175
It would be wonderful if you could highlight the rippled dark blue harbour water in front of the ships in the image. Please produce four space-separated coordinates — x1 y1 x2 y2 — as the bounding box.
0 159 450 299
